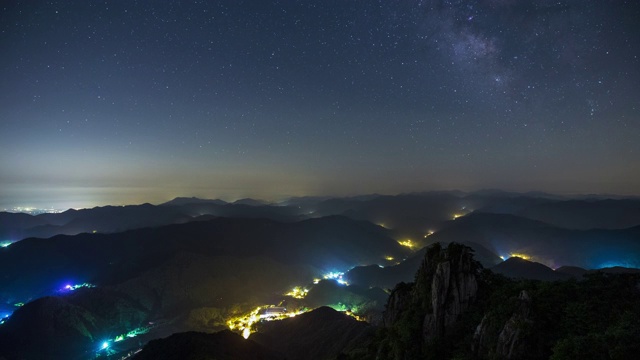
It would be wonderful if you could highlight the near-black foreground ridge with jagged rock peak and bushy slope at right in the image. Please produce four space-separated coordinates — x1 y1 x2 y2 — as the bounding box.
368 248 640 360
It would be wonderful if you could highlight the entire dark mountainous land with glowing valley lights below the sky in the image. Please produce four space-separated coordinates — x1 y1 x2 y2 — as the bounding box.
0 191 640 360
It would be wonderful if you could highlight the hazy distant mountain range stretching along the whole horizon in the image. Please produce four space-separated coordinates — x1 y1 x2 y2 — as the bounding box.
5 190 640 241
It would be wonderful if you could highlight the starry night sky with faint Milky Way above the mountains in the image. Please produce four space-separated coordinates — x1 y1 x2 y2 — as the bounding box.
0 0 640 208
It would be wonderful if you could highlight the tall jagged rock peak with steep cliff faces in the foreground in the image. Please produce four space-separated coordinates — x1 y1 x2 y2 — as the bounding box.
378 243 482 359
